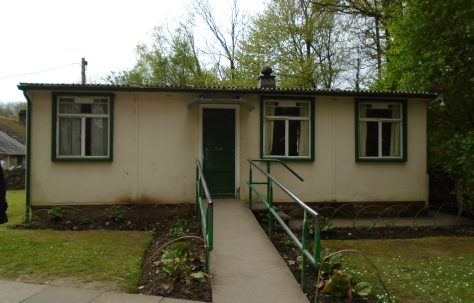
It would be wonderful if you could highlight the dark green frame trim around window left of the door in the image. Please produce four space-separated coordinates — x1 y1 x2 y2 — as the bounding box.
51 92 115 162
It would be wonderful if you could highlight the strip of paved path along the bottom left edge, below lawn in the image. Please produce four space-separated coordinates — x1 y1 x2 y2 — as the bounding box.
0 280 204 303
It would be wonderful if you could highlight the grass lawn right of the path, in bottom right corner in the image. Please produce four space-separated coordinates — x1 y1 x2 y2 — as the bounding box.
322 237 474 303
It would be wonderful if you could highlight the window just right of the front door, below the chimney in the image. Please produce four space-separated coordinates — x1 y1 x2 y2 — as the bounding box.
262 99 314 160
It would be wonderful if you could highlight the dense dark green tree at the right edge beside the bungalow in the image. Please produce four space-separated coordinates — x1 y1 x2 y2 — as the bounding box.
377 0 474 214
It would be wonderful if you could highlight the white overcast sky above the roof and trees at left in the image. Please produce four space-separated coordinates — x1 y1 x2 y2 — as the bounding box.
0 0 264 102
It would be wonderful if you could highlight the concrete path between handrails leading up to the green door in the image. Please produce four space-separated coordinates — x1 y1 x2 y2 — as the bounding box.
211 199 308 303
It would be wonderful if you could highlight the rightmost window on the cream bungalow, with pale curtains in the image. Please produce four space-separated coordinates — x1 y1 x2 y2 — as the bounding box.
356 101 406 161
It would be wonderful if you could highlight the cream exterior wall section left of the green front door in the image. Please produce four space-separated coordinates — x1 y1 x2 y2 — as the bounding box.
30 93 198 205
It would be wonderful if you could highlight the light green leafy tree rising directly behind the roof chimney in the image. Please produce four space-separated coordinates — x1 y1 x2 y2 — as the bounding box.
240 0 346 88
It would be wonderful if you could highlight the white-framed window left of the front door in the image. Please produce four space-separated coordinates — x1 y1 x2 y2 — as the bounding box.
53 95 113 160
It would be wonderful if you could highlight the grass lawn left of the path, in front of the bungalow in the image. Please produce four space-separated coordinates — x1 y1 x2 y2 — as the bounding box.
0 191 151 292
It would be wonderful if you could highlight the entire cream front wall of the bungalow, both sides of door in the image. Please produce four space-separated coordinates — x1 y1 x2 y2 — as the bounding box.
29 92 427 206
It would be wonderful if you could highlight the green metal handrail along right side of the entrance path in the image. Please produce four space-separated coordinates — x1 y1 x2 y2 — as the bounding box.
247 159 321 288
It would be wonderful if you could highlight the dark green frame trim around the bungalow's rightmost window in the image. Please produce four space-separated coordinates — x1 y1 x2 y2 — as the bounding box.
354 98 408 163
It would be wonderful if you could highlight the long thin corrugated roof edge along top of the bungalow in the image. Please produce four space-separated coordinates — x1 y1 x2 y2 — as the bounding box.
18 83 436 99
